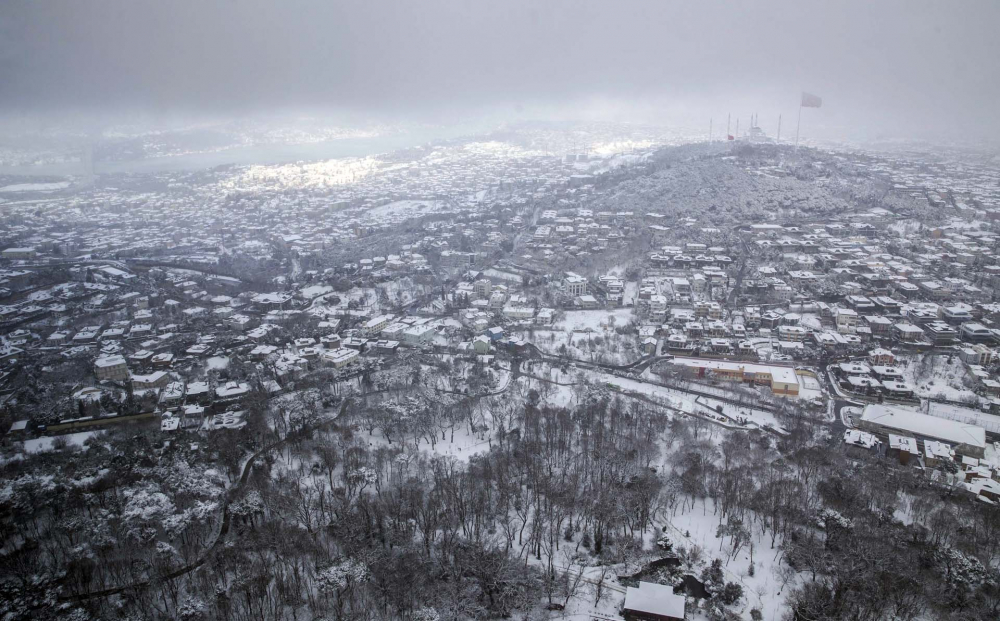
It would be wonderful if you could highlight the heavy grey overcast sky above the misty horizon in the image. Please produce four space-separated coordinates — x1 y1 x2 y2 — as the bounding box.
0 0 1000 138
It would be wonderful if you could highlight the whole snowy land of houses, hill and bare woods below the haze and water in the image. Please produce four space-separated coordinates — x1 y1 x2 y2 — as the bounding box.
0 123 1000 621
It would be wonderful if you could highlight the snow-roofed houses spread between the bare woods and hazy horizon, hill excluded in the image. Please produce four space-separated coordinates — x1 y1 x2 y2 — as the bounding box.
0 124 1000 480
